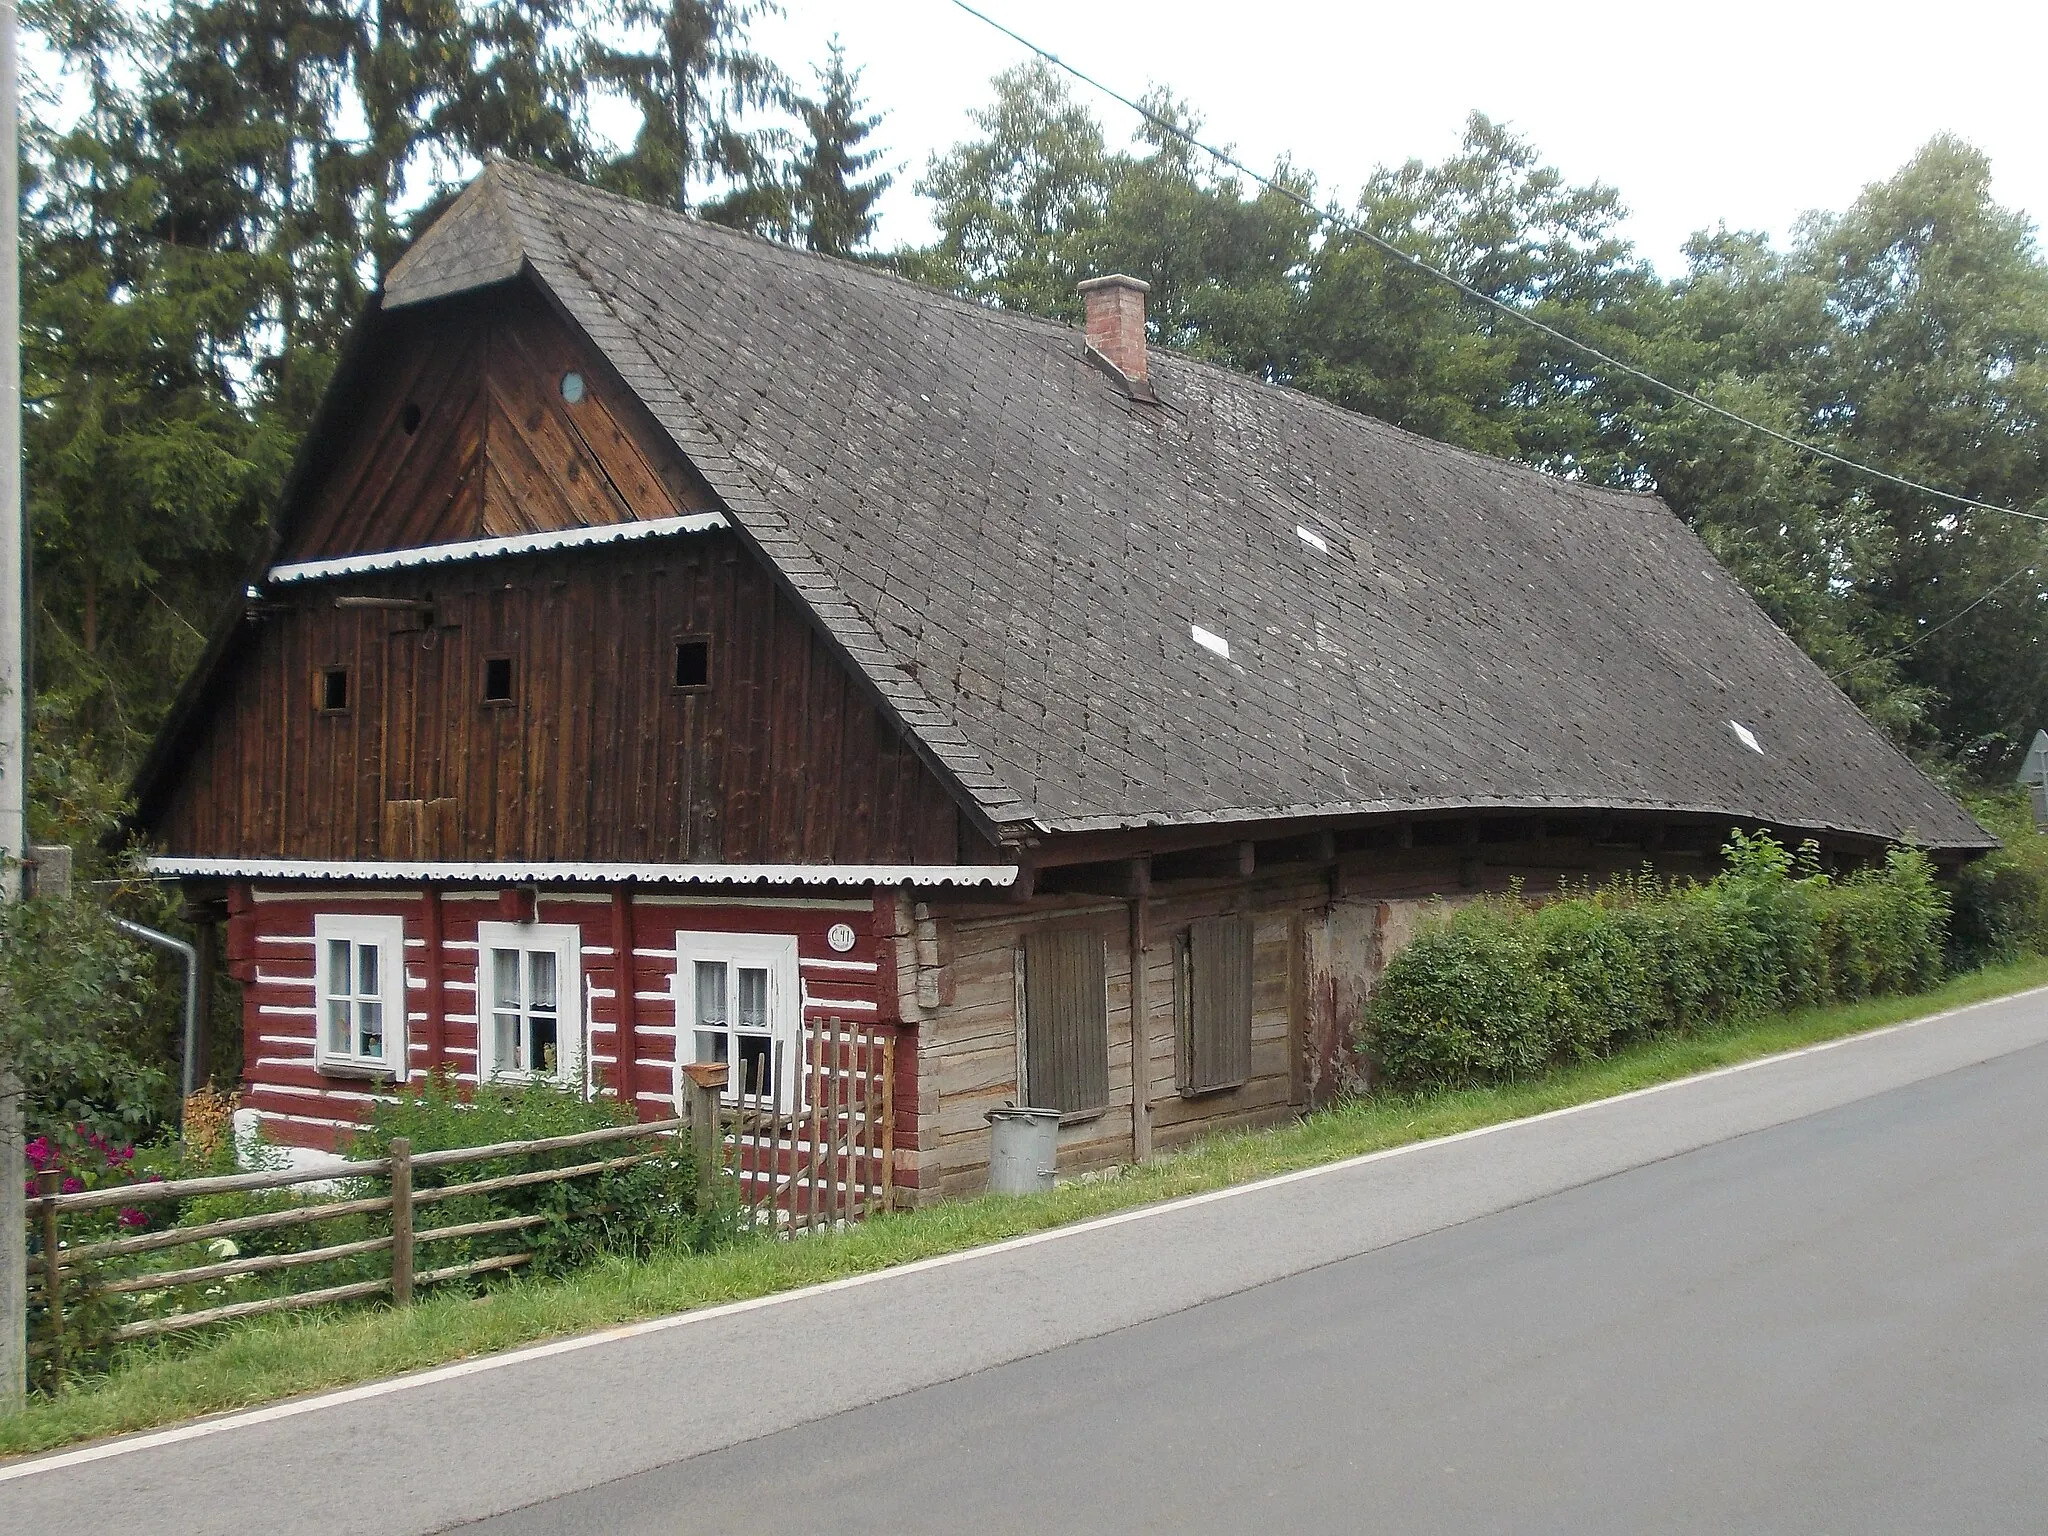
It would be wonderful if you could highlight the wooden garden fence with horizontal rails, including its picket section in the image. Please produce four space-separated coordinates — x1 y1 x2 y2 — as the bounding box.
27 1020 895 1384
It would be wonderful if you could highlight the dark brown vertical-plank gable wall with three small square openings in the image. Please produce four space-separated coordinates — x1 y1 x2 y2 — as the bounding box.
154 532 974 864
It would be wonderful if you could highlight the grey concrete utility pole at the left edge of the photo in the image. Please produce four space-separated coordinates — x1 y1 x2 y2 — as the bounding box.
0 0 29 1413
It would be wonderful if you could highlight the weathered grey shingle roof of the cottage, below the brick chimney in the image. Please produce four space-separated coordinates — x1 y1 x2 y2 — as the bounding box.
385 164 1993 848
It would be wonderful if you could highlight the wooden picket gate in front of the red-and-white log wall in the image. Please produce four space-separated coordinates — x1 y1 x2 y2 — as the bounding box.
723 1018 895 1233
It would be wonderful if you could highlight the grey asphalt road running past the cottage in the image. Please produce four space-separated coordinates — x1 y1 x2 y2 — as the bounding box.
0 993 2048 1532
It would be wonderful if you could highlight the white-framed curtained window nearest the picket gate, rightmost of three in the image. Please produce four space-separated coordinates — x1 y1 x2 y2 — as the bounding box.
676 934 803 1112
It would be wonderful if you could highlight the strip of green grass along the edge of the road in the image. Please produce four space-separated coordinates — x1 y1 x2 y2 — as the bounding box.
0 958 2048 1456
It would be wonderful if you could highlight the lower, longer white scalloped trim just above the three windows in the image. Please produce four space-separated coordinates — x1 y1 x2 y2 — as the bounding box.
150 854 1018 887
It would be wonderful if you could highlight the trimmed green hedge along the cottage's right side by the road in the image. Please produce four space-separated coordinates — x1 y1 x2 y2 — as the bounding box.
1362 831 1950 1087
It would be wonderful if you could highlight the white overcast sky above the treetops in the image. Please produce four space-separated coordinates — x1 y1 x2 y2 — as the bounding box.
756 0 2048 272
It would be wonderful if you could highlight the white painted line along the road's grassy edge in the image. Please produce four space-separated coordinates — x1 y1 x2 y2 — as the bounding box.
0 987 2048 1483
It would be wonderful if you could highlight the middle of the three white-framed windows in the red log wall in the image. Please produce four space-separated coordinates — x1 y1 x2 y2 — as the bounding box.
477 924 584 1083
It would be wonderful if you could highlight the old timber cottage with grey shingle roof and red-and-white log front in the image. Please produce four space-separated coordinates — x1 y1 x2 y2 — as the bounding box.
137 164 1993 1200
